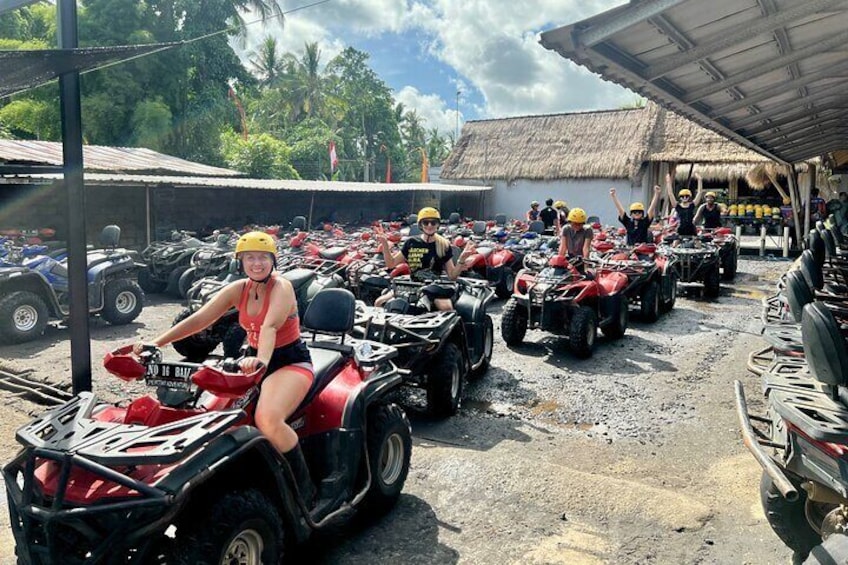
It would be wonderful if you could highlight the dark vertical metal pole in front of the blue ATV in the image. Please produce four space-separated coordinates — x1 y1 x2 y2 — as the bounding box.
57 0 91 394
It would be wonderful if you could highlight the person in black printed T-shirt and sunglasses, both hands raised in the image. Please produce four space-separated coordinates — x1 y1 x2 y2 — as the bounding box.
374 206 474 310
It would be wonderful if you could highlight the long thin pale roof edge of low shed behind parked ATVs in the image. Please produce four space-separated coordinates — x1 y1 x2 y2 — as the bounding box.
0 172 492 192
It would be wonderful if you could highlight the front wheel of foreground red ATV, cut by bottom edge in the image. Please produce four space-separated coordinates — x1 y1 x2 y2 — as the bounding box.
174 489 285 565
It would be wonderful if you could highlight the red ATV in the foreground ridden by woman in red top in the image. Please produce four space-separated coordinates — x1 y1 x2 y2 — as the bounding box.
3 289 411 564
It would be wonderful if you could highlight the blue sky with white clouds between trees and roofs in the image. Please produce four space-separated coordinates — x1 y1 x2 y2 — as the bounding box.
235 0 637 133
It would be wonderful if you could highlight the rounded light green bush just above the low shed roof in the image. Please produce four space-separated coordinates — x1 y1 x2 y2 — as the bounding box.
221 130 300 179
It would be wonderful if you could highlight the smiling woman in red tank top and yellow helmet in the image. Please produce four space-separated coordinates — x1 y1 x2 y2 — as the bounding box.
133 232 315 501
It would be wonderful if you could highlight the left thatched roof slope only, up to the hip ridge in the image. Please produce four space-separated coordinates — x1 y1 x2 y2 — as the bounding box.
441 109 652 180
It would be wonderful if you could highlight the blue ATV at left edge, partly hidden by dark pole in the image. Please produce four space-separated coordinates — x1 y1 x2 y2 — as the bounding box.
0 226 144 343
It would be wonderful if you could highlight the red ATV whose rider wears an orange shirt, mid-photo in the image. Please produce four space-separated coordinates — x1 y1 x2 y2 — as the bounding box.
501 255 629 358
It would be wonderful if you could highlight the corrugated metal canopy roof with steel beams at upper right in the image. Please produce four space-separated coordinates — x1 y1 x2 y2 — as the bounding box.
541 0 848 162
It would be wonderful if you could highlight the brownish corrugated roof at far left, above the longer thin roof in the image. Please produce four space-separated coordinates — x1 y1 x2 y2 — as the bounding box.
0 139 242 177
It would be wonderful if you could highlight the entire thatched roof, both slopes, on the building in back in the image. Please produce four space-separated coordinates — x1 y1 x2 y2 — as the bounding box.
441 102 768 180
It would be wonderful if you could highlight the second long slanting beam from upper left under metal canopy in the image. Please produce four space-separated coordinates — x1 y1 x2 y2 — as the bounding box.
644 0 848 81
